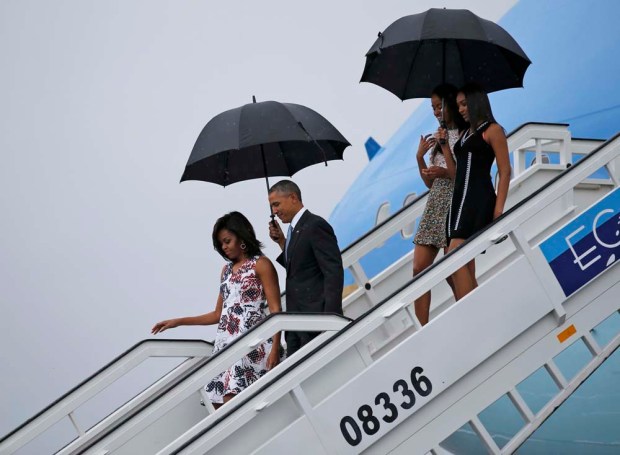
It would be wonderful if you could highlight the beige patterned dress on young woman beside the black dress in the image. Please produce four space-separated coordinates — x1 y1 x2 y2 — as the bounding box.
413 129 459 248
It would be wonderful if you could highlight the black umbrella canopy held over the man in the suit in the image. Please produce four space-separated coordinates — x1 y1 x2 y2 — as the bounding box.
181 101 351 186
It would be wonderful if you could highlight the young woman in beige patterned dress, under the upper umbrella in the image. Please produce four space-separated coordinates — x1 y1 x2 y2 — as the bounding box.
413 84 465 325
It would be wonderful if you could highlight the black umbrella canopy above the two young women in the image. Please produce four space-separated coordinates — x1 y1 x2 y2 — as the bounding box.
360 8 531 100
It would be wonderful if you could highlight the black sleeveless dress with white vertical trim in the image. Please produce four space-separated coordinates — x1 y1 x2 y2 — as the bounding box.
447 122 496 239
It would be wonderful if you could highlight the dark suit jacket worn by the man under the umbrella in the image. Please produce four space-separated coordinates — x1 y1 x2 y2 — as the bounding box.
276 210 344 314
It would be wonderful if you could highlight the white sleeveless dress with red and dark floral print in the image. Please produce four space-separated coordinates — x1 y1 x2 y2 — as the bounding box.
205 256 273 403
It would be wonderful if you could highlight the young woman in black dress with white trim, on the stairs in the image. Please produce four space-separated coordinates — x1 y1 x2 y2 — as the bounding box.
441 84 510 300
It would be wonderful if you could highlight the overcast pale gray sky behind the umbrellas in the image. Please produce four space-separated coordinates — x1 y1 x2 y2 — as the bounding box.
0 0 516 435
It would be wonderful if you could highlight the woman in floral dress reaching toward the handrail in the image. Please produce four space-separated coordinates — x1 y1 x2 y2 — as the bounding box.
151 212 281 408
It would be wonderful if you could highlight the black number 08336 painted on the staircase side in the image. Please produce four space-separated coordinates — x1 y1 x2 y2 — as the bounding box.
340 367 433 446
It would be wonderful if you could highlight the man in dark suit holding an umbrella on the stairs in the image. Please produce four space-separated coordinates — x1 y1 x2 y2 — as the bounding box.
269 180 344 355
